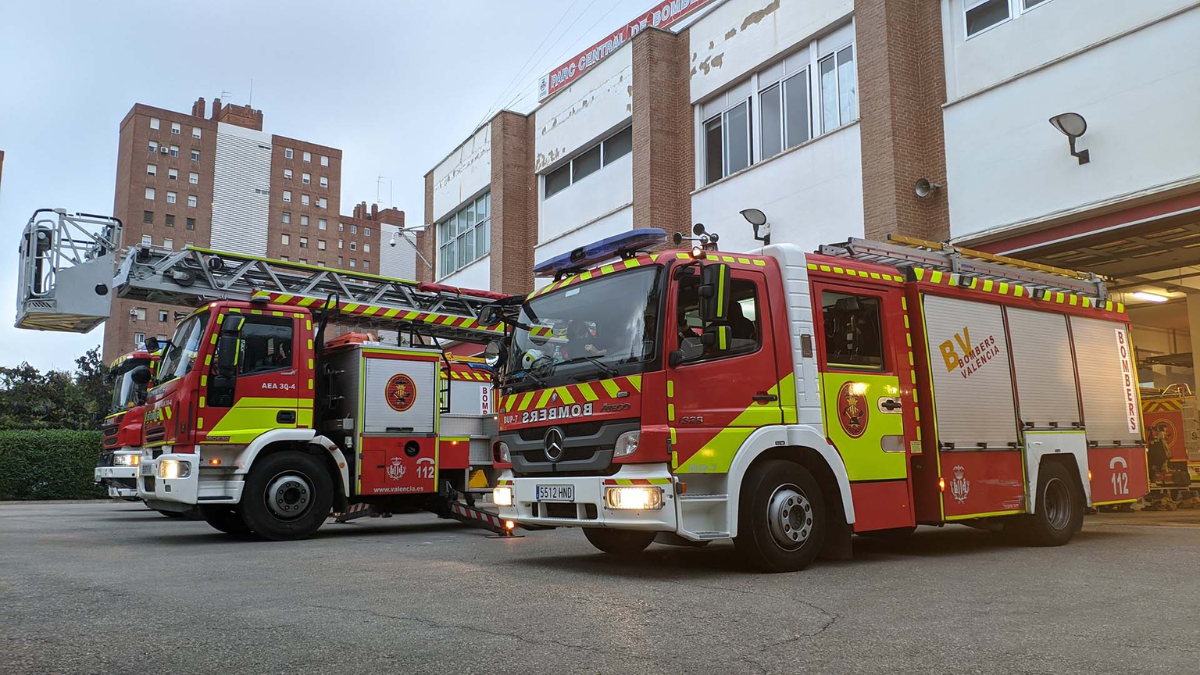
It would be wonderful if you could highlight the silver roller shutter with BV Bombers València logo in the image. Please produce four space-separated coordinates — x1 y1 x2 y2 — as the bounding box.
924 295 1016 448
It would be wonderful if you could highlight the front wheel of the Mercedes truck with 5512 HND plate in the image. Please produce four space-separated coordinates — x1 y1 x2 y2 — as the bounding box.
733 460 826 572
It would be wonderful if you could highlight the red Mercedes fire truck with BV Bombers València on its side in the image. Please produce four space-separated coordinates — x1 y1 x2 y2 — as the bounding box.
485 226 1147 571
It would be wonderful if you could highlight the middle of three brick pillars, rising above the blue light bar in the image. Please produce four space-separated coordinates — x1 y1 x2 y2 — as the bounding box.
632 29 695 239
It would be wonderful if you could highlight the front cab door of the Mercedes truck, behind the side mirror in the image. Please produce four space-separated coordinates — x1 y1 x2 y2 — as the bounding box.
664 268 786 473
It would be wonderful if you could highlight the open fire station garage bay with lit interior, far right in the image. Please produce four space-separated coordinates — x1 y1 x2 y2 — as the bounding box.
1003 211 1200 488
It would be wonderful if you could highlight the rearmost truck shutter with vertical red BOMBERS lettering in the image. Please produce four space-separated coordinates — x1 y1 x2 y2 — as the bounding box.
1070 316 1141 446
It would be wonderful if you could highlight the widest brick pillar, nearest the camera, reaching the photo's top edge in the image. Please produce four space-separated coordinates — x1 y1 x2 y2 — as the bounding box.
854 0 950 240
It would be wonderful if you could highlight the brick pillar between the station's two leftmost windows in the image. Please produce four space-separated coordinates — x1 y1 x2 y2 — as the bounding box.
492 110 538 293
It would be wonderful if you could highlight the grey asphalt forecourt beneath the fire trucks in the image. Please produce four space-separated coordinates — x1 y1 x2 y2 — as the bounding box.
0 502 1200 675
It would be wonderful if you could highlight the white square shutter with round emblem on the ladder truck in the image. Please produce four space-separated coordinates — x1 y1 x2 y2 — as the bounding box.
362 358 439 434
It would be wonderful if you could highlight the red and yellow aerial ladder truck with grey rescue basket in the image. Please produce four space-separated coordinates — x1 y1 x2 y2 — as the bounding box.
17 209 511 539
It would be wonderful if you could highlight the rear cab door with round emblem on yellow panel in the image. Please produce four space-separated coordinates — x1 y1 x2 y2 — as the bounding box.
812 281 916 531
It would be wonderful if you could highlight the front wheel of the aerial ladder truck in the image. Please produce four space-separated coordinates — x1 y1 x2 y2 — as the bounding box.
240 450 334 542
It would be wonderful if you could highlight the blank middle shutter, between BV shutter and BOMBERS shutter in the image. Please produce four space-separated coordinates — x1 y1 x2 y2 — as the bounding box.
1004 307 1081 429
